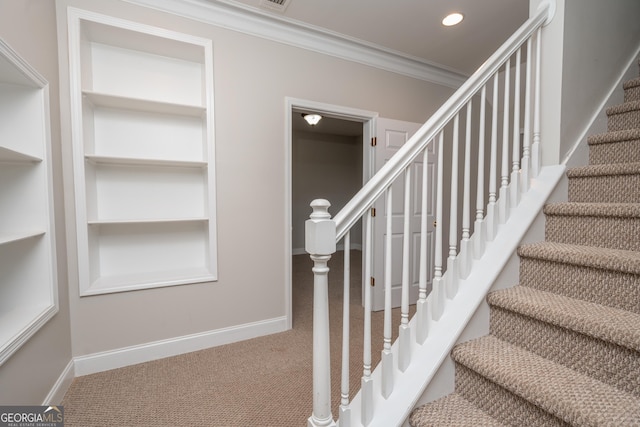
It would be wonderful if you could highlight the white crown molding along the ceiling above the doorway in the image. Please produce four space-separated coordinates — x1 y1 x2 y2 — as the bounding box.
123 0 468 89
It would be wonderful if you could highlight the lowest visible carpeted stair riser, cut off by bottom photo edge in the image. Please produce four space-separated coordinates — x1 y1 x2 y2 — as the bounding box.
455 363 570 427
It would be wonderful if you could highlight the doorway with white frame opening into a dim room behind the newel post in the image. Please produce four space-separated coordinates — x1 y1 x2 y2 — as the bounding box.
285 99 377 328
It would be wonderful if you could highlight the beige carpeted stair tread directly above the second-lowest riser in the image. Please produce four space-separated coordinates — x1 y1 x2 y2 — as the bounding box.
487 286 640 351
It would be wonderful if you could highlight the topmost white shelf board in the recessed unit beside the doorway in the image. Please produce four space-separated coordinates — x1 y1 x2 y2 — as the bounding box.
82 90 206 117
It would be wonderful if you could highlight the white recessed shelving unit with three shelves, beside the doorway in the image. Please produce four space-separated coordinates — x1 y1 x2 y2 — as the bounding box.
68 8 217 296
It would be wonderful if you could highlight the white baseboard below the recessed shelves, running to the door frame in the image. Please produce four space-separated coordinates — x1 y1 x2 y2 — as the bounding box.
73 316 287 376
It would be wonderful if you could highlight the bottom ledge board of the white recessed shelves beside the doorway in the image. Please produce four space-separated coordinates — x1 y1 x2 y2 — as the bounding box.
82 267 217 296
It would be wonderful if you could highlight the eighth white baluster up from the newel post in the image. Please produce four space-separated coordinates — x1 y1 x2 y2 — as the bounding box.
459 100 473 279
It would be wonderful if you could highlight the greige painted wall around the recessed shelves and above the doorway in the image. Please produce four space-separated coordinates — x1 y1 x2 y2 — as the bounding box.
52 0 452 362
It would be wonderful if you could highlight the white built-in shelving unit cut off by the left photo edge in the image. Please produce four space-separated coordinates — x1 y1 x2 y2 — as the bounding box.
0 39 58 364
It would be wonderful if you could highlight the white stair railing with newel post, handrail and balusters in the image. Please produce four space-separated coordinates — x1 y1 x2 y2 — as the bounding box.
305 3 553 427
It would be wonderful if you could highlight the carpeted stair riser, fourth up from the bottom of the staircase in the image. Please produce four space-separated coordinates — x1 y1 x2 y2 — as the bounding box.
545 215 640 251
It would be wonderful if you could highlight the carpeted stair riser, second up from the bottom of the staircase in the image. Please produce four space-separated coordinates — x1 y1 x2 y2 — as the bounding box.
490 306 640 397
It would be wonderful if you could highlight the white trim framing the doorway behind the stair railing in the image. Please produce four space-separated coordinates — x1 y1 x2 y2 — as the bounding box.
284 97 378 329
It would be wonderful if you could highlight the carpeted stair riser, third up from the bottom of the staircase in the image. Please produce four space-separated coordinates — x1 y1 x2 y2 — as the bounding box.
520 257 640 314
